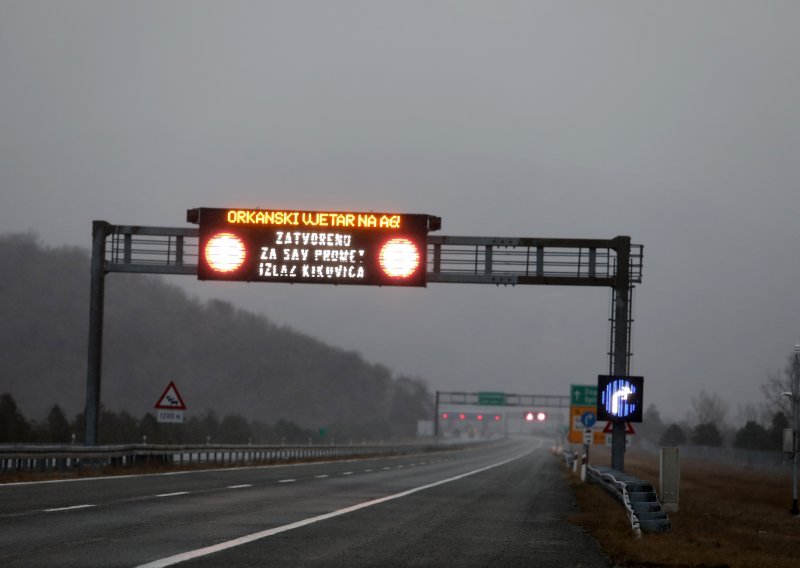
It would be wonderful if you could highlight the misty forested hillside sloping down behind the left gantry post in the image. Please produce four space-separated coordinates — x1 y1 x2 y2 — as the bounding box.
0 231 432 438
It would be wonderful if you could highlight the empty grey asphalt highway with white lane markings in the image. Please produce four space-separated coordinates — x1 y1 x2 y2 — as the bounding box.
0 438 609 568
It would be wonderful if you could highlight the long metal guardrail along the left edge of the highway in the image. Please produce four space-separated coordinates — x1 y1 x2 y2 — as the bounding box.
0 442 490 475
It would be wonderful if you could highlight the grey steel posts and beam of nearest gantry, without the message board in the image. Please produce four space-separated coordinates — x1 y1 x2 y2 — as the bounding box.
85 221 643 470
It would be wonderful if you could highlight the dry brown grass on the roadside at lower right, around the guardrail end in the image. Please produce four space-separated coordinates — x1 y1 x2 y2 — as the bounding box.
569 450 800 568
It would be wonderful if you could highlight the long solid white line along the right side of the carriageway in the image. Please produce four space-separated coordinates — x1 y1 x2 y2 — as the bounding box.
136 450 533 568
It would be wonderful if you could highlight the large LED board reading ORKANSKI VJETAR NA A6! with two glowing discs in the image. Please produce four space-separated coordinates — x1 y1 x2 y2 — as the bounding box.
187 208 441 286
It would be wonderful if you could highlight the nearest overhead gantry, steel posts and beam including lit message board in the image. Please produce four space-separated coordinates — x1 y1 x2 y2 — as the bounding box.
86 208 643 470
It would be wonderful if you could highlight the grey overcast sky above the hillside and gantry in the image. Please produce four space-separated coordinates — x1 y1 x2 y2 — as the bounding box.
0 0 800 420
